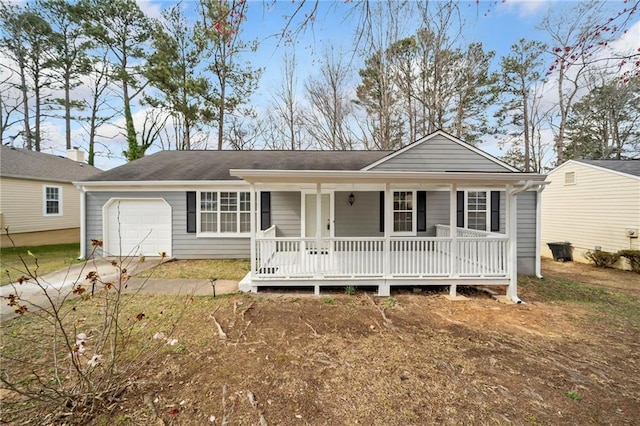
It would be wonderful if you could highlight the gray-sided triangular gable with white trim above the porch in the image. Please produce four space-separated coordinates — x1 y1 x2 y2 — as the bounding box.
363 130 520 172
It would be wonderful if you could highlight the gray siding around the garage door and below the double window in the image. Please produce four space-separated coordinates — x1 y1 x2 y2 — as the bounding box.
86 191 250 259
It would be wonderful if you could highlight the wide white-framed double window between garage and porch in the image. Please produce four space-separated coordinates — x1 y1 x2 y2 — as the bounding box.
200 191 251 234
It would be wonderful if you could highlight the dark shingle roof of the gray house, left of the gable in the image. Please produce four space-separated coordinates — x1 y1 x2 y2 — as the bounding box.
85 150 393 182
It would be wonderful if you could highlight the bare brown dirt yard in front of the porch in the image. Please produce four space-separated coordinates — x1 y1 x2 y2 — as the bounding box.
3 262 640 425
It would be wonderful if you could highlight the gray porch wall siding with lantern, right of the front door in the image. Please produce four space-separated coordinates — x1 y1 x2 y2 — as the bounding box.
334 191 384 237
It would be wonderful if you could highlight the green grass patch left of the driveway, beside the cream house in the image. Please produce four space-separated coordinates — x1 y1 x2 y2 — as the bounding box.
0 244 82 285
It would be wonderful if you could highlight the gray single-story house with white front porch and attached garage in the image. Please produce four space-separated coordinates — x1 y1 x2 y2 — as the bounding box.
76 131 544 301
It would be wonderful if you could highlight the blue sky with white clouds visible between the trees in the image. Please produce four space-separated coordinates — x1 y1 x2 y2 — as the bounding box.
7 0 640 169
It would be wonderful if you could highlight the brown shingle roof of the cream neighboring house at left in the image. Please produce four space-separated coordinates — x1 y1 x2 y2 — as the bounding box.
0 145 102 182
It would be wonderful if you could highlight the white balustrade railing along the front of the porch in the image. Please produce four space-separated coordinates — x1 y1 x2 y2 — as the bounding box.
254 234 508 279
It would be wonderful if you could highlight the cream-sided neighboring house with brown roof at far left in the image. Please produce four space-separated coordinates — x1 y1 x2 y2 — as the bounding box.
0 145 101 247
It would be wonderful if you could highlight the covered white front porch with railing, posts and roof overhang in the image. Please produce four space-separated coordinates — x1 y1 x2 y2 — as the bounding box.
233 170 544 301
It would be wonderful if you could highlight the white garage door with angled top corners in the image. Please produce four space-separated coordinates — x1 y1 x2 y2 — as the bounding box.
105 199 171 256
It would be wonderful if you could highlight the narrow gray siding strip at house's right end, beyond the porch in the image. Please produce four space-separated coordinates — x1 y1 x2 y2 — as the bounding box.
517 191 538 275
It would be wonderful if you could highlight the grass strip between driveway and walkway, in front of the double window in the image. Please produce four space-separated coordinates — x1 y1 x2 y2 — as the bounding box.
137 259 251 281
